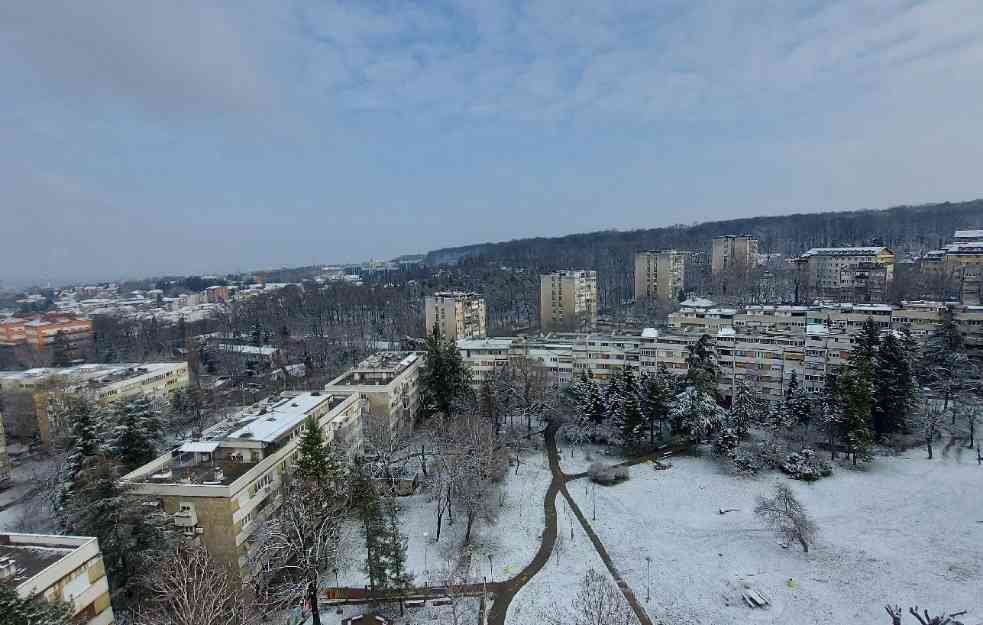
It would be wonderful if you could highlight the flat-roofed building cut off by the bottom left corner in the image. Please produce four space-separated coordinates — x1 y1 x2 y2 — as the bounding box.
0 533 113 625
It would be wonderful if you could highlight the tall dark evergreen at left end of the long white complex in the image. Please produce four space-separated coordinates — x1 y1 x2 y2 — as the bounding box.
420 324 473 418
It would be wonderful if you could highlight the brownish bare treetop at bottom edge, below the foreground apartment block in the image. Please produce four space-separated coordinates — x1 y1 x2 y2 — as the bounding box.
132 542 260 625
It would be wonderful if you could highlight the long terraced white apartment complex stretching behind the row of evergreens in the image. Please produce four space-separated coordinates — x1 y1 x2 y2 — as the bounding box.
457 299 983 401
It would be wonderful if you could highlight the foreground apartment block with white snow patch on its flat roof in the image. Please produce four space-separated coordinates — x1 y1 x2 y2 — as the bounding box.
122 391 364 577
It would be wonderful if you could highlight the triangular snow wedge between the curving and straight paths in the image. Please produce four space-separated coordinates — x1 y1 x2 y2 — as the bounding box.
506 492 624 625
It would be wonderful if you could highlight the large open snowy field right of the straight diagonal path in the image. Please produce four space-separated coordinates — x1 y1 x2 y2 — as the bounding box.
569 450 983 625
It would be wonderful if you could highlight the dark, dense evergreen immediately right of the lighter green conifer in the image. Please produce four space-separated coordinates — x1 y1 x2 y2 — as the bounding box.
872 333 916 436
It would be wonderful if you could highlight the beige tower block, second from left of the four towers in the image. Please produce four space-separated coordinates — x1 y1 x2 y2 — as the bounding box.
539 270 598 332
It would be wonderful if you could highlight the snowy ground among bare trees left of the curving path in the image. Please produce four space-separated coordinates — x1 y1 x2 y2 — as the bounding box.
336 450 551 586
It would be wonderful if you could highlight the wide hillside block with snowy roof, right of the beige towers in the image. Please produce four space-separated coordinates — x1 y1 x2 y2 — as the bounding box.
796 247 894 300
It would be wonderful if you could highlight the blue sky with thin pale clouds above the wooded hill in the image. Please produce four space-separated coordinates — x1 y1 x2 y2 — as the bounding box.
0 0 983 286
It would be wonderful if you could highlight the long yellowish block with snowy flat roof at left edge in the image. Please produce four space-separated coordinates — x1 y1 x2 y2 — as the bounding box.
0 362 189 445
